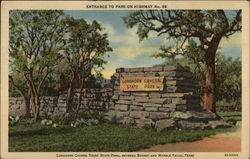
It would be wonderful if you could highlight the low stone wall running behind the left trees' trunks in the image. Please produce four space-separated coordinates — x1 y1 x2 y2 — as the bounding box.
9 88 113 116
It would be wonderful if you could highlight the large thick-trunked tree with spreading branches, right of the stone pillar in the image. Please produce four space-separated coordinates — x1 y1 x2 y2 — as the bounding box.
124 10 242 112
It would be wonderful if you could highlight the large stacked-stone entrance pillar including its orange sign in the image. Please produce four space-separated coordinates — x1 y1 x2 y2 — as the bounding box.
105 66 228 130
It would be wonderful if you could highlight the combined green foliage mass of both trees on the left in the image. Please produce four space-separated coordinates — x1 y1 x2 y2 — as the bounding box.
9 10 112 119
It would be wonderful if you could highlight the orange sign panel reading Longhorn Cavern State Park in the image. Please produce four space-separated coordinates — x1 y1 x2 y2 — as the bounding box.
120 77 164 91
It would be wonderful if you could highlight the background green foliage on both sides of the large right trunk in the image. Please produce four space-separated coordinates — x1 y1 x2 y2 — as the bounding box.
158 52 242 106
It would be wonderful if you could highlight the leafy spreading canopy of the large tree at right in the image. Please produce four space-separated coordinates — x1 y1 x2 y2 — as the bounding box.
123 10 241 57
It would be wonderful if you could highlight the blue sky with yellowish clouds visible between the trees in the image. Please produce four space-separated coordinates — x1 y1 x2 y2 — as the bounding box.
65 10 241 79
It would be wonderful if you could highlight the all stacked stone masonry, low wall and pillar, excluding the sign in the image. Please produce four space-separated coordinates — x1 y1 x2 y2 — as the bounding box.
9 66 229 130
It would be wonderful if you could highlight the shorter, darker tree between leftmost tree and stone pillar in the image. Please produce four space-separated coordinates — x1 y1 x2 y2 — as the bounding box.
63 18 112 113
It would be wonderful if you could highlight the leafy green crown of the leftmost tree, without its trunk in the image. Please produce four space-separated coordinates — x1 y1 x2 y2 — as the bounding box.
9 10 65 75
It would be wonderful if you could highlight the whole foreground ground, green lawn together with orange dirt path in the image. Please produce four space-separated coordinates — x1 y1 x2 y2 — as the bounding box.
9 113 241 152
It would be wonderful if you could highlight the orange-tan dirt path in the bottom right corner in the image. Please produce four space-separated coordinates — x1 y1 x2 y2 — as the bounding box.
139 128 241 152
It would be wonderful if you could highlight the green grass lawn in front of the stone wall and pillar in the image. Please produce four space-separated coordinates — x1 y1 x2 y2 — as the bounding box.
9 118 236 152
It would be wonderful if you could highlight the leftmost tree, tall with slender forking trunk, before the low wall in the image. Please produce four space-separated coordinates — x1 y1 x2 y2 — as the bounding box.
9 10 65 121
